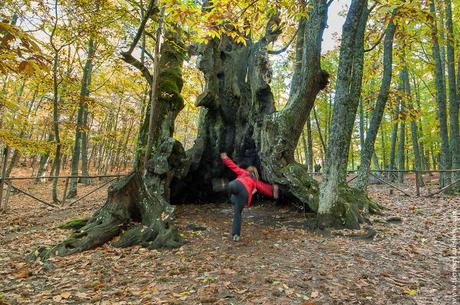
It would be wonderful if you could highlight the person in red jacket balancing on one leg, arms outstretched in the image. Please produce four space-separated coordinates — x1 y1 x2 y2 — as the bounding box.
220 153 278 241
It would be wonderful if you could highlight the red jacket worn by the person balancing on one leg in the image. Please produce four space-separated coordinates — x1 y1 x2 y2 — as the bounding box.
222 157 273 208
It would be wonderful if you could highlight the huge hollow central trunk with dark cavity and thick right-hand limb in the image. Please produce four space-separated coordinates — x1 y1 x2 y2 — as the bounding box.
173 0 327 209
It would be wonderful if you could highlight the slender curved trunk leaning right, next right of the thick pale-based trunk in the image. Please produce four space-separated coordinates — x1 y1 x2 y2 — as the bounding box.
356 13 398 191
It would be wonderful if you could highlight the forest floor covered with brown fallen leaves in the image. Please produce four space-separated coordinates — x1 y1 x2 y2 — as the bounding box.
0 172 460 305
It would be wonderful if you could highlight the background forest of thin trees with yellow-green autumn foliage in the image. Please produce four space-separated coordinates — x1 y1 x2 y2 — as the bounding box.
0 1 460 193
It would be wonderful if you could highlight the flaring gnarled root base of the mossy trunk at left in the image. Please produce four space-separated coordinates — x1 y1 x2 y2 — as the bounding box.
27 172 182 261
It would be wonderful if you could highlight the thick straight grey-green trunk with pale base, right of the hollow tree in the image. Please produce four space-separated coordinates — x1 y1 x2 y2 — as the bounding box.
318 0 369 227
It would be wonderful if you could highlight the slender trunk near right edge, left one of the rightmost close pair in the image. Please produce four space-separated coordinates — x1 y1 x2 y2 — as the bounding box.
430 0 451 187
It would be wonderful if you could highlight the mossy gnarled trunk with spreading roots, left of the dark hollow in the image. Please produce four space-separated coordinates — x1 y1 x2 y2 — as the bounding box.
30 25 188 259
